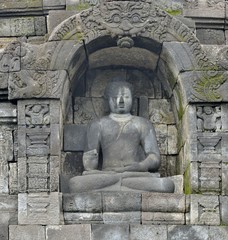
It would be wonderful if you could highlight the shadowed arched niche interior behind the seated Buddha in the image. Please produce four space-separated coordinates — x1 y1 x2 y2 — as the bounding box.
63 37 178 190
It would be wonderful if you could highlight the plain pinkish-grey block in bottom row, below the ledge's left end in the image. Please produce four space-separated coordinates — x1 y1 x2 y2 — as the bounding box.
46 224 91 240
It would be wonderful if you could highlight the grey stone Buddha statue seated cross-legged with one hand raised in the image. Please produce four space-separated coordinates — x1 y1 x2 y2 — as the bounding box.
69 81 174 193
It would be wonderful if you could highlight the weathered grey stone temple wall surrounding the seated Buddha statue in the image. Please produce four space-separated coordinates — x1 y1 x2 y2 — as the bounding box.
0 0 228 240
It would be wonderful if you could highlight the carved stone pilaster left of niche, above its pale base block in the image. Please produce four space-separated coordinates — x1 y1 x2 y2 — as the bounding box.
18 100 60 192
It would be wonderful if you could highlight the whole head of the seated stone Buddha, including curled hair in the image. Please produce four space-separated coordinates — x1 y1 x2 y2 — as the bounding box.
106 79 133 114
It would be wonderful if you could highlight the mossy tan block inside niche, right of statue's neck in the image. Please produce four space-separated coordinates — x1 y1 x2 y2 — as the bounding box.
149 99 175 124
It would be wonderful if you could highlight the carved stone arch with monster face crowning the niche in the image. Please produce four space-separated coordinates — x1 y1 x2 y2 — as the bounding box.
49 0 213 68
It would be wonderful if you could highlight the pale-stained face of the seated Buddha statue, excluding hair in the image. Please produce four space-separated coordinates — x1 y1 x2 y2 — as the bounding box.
109 87 132 114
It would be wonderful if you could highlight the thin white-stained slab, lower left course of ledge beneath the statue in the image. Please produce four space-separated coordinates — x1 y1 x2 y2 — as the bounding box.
64 212 103 224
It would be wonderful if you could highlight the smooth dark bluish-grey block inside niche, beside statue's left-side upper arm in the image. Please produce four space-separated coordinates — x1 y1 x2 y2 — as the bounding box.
64 125 86 151
